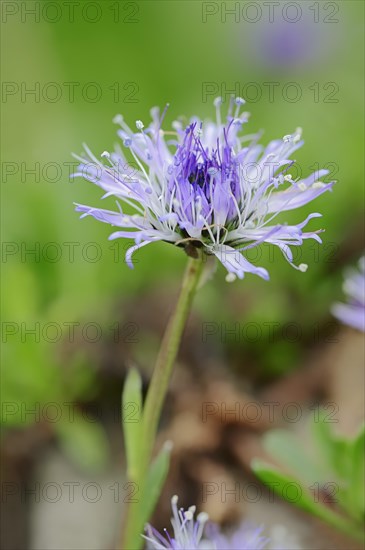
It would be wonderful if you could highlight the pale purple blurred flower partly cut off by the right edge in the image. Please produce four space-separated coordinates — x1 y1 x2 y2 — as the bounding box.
332 256 365 332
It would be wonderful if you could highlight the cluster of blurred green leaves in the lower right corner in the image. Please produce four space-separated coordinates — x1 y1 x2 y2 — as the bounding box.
253 409 365 538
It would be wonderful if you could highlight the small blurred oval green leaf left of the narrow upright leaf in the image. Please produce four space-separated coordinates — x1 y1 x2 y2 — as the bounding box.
54 409 109 472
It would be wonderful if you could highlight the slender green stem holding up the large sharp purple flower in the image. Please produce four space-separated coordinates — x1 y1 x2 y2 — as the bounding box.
121 258 204 549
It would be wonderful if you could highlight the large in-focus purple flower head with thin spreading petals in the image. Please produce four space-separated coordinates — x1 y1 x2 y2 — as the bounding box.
75 98 333 281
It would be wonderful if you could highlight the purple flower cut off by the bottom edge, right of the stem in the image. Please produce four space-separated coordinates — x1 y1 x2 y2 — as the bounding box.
144 496 268 550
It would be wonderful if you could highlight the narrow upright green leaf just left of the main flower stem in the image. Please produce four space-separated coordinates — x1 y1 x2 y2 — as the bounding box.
122 368 143 481
